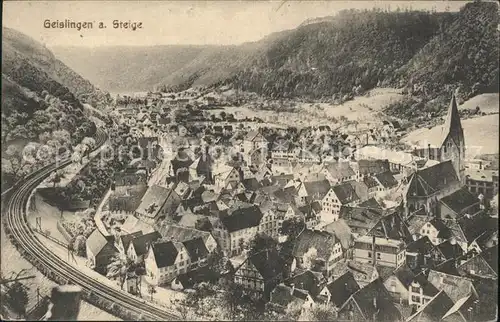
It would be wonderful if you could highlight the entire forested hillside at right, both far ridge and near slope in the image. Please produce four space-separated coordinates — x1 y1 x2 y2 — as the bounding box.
231 2 498 99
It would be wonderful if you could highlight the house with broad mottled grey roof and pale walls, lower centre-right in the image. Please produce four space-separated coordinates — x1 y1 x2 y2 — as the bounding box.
292 229 343 278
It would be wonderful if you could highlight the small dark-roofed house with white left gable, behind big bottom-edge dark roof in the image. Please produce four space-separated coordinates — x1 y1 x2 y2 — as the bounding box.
319 271 360 308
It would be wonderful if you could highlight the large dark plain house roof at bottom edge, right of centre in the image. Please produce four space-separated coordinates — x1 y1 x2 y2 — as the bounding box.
338 279 402 322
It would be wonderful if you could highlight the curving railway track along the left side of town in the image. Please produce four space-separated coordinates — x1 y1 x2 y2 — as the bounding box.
4 131 181 321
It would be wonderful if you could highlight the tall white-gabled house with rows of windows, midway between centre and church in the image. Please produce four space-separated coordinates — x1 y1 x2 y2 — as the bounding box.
321 182 360 222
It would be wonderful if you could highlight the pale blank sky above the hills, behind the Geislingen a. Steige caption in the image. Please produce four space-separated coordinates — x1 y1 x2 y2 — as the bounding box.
2 0 466 47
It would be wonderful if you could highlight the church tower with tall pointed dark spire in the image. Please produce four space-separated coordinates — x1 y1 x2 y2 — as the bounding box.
440 95 465 182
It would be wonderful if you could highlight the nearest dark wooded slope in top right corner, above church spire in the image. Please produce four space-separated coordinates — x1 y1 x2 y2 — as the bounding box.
388 2 499 99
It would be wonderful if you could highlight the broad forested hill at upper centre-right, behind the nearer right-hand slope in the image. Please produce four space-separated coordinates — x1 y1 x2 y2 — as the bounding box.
227 10 456 98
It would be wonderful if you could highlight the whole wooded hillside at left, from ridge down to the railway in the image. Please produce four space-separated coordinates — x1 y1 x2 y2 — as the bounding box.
2 28 109 191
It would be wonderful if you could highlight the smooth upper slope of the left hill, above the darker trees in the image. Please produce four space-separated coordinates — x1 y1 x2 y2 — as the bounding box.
2 27 107 107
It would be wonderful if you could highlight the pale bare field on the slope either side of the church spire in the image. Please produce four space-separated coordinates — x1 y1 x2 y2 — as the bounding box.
402 114 499 158
